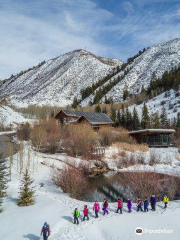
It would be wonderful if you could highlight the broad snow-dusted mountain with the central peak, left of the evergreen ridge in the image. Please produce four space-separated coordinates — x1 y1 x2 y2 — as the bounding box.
0 49 122 106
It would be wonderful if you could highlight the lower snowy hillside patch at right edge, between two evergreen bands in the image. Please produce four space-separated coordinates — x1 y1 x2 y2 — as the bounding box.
130 90 180 121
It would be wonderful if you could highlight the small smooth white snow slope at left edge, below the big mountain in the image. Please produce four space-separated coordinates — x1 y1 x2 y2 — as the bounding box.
0 105 28 127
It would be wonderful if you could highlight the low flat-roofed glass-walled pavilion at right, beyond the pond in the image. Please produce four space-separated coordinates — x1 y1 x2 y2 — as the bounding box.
129 129 175 147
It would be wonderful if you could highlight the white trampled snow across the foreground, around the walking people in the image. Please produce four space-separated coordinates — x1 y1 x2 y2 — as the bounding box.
0 143 180 240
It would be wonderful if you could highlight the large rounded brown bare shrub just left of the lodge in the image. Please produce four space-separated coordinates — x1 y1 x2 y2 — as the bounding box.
31 119 61 153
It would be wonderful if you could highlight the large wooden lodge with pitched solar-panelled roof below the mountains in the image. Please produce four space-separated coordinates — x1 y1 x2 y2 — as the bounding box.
55 110 114 130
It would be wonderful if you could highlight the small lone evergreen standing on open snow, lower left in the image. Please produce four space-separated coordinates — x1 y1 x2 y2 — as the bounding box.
18 169 35 206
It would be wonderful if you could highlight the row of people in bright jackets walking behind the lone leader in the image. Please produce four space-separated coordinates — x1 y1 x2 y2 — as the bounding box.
73 195 169 224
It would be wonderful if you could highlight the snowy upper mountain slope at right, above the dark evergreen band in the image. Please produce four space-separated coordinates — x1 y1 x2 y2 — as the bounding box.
102 38 180 102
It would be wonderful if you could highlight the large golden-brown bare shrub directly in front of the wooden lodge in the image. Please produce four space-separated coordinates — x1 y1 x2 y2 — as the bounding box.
62 125 98 159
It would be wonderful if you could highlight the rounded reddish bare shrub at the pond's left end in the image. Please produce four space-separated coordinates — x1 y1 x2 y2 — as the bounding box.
52 166 89 199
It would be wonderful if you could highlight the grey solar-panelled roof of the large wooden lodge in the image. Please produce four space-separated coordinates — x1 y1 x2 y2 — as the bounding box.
59 110 114 124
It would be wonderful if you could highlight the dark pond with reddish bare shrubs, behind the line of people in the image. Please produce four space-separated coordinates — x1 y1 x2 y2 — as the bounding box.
83 172 180 202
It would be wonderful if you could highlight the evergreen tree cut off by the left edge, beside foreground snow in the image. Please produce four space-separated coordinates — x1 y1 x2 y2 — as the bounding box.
0 155 9 212
